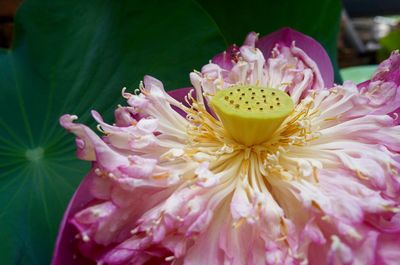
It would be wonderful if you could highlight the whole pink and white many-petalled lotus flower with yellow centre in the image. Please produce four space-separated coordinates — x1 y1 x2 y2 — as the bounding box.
53 29 400 265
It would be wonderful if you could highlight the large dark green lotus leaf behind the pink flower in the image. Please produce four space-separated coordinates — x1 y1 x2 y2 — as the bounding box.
0 0 340 265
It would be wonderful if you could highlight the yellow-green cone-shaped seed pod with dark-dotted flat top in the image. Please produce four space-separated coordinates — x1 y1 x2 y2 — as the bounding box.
211 85 294 146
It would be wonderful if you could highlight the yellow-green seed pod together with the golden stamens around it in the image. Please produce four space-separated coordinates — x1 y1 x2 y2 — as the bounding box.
185 86 320 184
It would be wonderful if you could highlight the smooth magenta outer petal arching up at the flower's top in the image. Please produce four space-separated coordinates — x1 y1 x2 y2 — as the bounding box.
256 28 333 87
